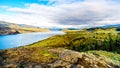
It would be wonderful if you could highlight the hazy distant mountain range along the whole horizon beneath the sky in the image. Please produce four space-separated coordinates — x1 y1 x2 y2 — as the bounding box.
0 21 120 35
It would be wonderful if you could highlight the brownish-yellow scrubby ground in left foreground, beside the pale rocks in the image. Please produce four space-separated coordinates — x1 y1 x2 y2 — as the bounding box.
0 47 59 68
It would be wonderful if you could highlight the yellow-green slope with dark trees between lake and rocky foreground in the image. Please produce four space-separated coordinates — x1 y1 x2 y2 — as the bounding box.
29 29 120 53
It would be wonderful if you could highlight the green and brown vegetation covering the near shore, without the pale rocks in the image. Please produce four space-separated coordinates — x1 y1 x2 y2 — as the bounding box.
0 28 120 68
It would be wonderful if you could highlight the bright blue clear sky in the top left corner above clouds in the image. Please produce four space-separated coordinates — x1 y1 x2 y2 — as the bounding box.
0 0 48 13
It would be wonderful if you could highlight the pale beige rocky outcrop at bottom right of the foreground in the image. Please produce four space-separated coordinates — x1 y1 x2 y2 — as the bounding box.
51 50 115 68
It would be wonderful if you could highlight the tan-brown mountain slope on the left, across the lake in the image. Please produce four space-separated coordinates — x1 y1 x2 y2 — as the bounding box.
0 21 49 35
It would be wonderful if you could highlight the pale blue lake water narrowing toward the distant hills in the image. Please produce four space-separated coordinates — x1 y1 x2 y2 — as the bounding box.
0 31 65 50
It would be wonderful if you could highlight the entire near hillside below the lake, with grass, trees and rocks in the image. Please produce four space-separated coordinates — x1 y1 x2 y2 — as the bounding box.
0 29 120 68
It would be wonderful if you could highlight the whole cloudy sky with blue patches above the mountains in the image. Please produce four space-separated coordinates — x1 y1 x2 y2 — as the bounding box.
0 0 120 28
